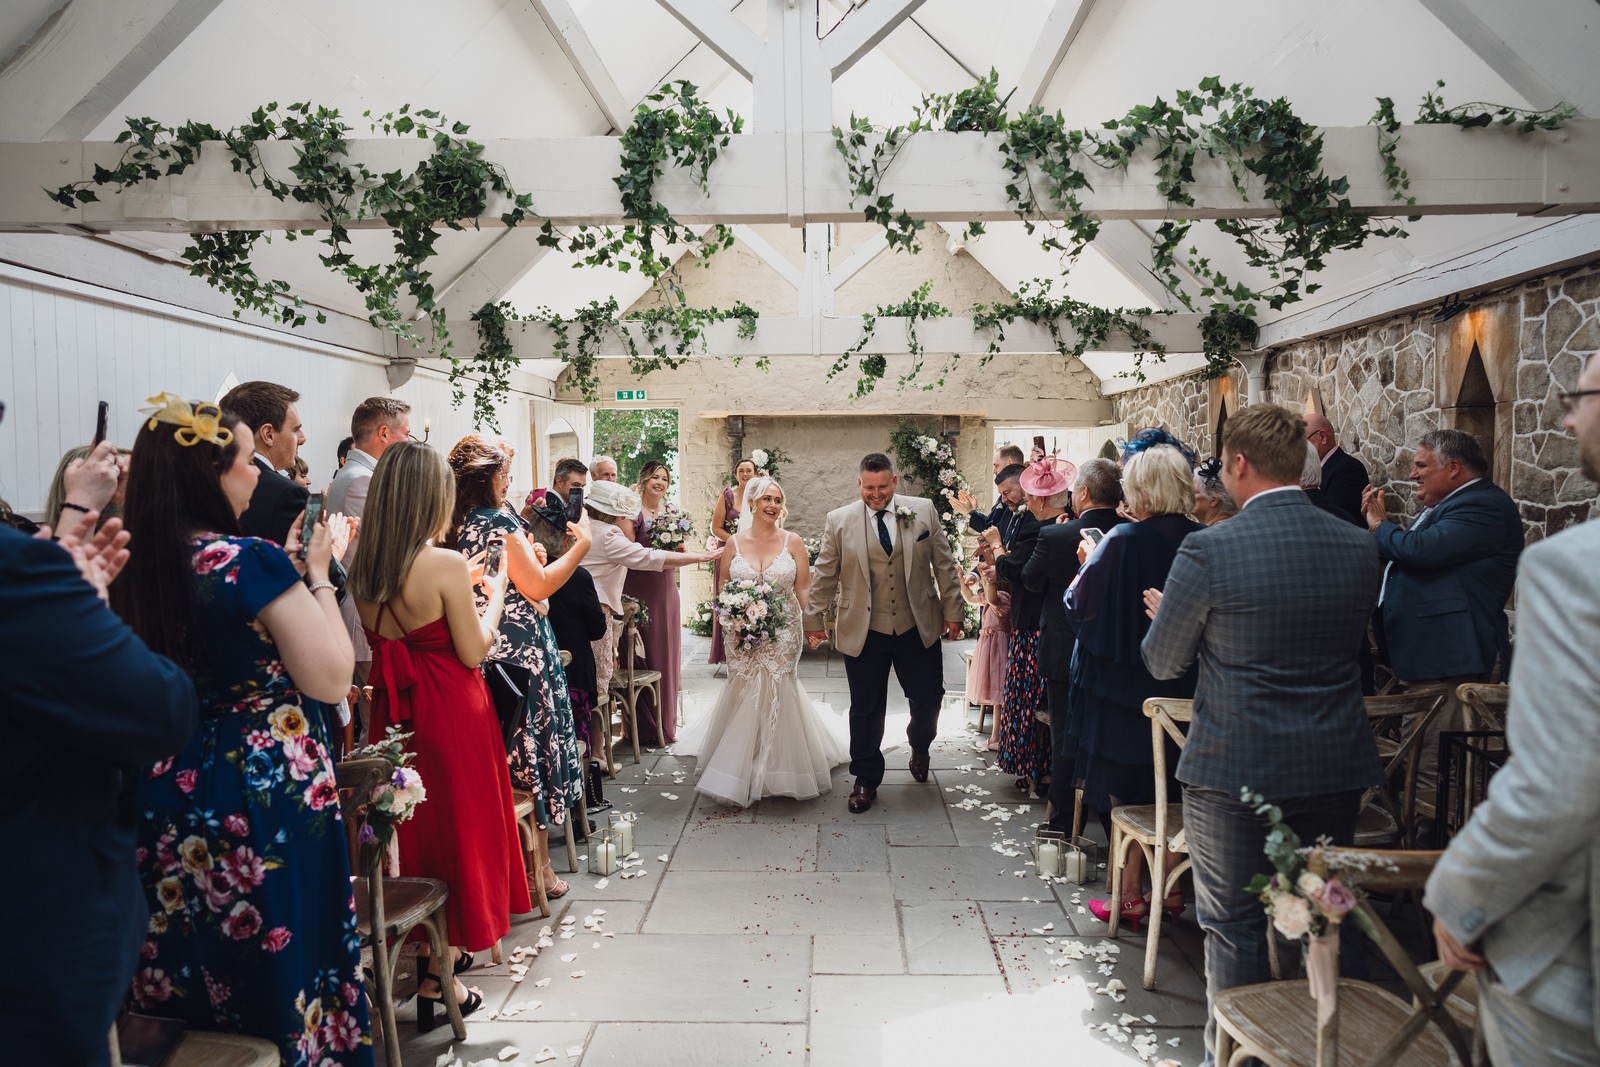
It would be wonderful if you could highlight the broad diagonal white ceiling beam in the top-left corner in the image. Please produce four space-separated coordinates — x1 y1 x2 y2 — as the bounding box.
0 0 221 141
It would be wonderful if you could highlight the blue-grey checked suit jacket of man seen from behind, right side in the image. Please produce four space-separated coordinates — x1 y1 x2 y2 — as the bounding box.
1141 490 1384 800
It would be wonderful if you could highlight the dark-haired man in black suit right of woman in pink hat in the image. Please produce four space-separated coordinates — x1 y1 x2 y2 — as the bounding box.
1022 459 1128 832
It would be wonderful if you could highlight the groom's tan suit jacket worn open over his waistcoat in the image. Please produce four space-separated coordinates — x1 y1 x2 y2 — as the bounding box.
805 496 962 656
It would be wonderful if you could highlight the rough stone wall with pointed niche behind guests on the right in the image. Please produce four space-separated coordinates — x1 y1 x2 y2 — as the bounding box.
1112 257 1600 544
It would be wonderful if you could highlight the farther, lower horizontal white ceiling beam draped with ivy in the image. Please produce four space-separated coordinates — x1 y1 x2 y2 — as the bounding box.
402 314 1202 360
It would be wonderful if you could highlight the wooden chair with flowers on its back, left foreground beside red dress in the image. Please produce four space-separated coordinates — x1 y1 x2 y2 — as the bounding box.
334 760 467 1067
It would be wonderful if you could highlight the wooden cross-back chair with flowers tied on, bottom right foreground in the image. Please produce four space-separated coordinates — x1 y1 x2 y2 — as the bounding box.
1213 848 1472 1067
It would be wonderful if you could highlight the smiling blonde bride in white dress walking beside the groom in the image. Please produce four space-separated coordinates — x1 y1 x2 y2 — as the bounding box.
685 477 850 808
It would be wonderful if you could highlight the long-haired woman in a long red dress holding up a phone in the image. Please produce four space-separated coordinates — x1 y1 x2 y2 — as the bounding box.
350 442 533 1030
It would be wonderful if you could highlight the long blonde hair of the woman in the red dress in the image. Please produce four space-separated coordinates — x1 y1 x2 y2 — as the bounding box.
349 442 456 605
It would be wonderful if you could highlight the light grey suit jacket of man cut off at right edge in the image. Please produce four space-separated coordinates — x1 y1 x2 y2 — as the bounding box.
1427 523 1600 1043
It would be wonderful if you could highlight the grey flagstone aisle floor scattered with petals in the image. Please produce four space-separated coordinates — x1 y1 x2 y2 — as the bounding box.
390 635 1205 1067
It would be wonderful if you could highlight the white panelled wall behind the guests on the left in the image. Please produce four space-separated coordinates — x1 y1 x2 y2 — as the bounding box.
0 264 534 515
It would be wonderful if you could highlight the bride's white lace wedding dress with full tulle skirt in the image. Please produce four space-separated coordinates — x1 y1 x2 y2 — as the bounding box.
682 537 850 808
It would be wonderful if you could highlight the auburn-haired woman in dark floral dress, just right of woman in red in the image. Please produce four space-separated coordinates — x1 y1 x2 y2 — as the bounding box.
450 434 589 897
